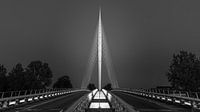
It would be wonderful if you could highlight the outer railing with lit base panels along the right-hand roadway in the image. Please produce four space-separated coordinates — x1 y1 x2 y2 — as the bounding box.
114 89 200 109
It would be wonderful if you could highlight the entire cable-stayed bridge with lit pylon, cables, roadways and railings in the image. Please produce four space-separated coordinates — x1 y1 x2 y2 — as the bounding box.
0 10 200 112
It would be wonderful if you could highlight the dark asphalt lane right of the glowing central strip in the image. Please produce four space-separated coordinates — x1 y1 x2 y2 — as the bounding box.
112 91 193 112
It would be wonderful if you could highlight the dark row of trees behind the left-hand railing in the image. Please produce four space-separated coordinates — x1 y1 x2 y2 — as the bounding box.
0 61 72 91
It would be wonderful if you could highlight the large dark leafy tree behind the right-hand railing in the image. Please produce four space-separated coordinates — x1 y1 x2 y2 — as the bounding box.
166 51 200 91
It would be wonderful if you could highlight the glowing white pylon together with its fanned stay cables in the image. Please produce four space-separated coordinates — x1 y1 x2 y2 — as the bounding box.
81 9 119 90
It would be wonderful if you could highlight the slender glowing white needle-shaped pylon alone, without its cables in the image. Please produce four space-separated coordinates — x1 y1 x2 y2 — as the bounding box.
98 9 103 90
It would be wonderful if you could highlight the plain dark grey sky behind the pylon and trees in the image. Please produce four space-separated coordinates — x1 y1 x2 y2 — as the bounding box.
0 0 200 88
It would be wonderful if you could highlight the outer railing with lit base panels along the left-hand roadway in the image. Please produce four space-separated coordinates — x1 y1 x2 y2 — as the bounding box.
0 89 85 110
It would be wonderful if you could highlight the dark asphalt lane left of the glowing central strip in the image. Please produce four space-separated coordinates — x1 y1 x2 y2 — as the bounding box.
6 92 87 112
